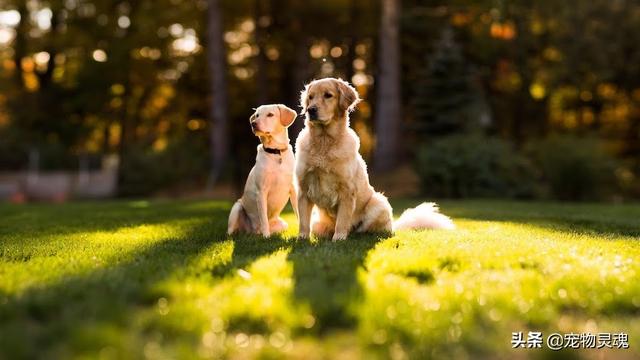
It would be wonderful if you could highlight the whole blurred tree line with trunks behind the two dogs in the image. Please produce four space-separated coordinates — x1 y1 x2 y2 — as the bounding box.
0 0 640 199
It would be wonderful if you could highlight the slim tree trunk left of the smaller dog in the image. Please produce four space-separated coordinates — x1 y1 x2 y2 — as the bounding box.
207 0 229 189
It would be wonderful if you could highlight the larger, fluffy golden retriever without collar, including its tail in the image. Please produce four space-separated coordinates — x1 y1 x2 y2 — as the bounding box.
296 78 454 241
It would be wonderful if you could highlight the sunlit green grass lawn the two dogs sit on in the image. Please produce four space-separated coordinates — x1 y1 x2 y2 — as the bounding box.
0 201 640 359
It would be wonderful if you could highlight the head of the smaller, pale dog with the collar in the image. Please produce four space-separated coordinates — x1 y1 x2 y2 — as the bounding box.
249 104 297 136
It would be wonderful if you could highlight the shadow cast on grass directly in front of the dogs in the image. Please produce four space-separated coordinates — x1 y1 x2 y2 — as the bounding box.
212 234 387 333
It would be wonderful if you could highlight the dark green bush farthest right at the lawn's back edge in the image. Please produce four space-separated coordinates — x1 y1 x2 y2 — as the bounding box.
530 135 617 200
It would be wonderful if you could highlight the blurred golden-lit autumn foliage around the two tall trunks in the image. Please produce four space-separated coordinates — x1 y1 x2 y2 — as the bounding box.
0 0 640 198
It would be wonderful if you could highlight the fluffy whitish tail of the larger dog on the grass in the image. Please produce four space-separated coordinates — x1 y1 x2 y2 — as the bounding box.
393 202 456 231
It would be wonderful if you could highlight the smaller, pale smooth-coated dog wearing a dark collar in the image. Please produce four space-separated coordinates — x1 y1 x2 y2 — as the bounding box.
227 104 298 237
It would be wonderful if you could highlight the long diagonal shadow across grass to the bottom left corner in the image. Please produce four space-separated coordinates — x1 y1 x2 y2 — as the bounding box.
0 208 227 359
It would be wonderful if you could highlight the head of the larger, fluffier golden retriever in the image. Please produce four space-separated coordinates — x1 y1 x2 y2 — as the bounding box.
300 78 360 125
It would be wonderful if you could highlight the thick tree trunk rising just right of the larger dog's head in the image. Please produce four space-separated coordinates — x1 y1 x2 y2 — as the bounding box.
374 0 402 171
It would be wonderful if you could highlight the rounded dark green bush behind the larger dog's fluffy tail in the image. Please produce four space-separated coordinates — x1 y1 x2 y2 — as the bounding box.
416 135 538 198
